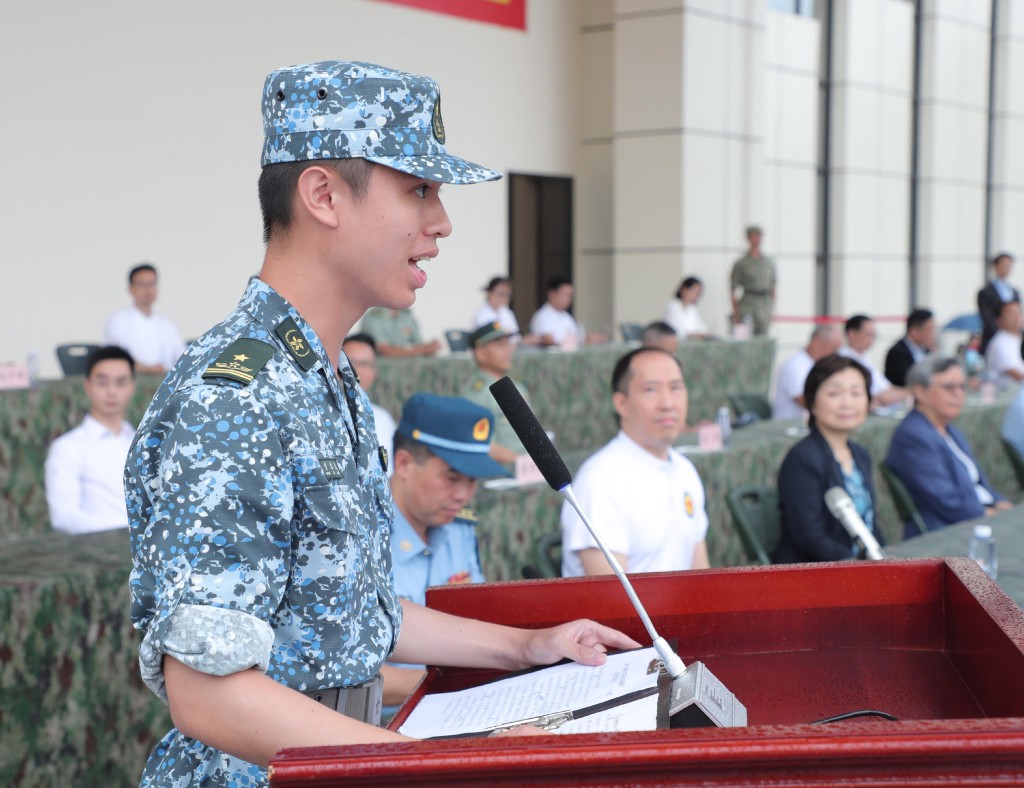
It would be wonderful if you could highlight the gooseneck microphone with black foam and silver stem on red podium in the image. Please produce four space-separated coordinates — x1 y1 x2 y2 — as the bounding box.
490 376 746 728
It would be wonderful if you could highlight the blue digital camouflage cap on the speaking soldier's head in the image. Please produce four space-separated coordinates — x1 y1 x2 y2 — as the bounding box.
262 60 502 183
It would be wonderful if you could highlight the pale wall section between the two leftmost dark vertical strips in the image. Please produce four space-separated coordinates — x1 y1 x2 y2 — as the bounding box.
829 0 913 360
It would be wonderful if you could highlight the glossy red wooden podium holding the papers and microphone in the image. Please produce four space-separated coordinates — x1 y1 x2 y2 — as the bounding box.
270 558 1024 787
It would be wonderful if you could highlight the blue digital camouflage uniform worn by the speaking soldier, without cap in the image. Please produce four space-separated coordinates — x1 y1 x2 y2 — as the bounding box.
125 278 401 786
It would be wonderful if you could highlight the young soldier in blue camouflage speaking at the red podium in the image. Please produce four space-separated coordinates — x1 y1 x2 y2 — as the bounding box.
125 60 638 787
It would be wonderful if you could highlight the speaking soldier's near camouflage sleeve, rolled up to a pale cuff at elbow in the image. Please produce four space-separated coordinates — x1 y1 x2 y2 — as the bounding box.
125 385 293 701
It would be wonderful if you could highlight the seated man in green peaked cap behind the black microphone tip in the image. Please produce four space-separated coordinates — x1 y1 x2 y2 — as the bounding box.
460 322 529 463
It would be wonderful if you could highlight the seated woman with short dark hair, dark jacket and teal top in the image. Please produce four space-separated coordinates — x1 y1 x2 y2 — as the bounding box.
772 354 885 564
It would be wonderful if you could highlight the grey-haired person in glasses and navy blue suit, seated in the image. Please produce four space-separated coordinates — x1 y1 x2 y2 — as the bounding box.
886 355 1011 537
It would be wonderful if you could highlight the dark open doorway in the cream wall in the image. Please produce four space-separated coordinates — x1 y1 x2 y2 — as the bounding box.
509 173 572 333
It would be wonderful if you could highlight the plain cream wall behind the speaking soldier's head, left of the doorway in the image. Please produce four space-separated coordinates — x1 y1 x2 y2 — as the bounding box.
0 0 580 377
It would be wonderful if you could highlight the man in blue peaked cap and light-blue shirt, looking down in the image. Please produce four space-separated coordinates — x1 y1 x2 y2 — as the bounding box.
381 393 506 707
